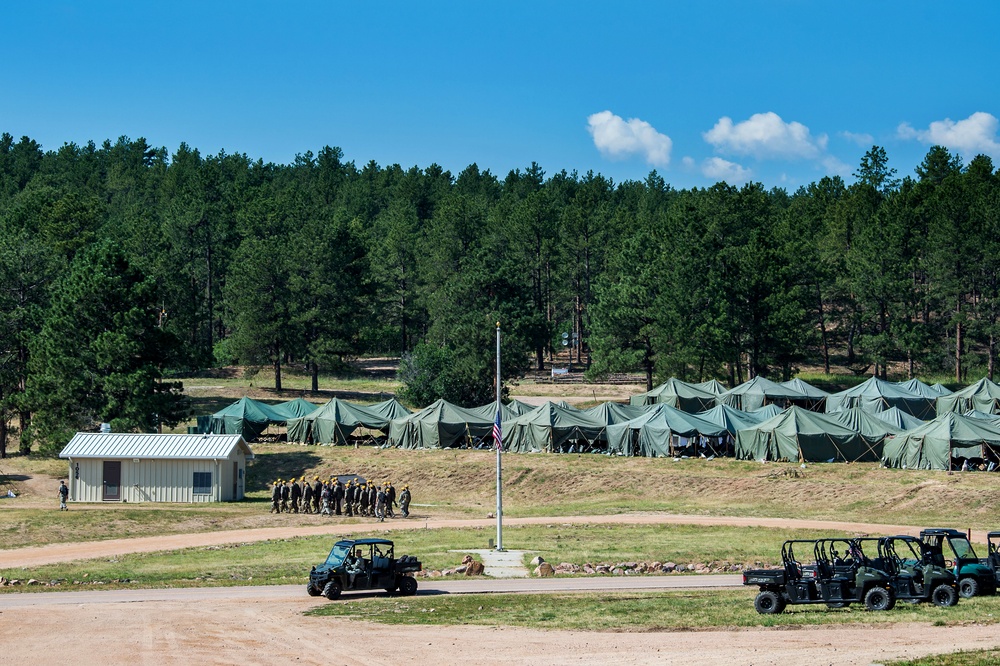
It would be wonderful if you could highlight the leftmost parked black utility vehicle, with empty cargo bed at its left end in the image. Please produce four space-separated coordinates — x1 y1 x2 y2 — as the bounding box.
743 539 896 614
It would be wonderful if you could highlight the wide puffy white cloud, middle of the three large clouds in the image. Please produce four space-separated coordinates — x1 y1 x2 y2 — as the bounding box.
702 111 827 159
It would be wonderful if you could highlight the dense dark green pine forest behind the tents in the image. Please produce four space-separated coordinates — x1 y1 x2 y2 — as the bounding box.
0 134 1000 454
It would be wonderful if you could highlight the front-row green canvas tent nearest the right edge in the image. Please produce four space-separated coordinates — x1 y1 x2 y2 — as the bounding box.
883 412 1000 470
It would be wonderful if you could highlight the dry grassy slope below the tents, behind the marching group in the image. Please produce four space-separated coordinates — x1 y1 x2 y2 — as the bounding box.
7 445 1000 548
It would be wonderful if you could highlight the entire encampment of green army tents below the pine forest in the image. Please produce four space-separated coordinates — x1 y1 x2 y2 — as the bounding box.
205 377 1000 469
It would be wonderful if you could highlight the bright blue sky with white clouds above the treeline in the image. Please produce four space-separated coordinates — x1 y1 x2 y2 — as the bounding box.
0 0 1000 190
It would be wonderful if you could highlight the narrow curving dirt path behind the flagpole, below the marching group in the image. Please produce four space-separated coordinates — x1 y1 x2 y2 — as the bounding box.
0 513 986 569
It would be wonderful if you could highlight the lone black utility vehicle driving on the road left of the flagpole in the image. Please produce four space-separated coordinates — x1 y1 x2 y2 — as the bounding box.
306 539 422 599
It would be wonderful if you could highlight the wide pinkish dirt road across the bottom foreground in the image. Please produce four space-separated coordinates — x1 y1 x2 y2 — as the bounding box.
0 594 1000 666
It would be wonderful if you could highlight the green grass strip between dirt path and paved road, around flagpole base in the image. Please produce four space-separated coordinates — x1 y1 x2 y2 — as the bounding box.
0 524 826 592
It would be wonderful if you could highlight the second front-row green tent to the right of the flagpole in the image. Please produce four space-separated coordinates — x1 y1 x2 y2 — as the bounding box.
607 405 728 458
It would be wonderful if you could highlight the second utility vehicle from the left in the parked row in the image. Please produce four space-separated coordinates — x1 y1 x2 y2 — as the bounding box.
854 536 958 606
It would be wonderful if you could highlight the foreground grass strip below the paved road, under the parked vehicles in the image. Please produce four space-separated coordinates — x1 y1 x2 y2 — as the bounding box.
308 590 1000 628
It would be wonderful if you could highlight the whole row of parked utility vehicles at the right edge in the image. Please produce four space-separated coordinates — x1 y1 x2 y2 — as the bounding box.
743 528 1000 614
